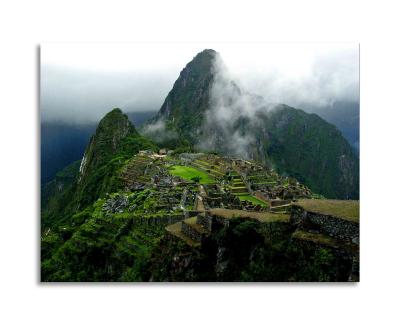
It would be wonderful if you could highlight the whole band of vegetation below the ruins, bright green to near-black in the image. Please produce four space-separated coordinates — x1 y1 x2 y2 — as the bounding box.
42 192 350 281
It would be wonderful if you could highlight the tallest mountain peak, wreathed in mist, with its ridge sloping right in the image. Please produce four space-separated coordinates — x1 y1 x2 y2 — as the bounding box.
145 50 359 199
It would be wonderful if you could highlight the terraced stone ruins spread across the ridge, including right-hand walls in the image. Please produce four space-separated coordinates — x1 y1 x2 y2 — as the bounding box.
103 152 359 281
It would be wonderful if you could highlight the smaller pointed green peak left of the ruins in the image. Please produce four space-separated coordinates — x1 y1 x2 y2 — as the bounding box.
42 108 157 228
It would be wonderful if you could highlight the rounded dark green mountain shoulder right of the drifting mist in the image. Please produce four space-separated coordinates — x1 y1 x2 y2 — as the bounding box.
261 106 359 199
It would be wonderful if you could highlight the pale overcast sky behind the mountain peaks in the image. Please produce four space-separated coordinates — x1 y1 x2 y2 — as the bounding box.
40 43 359 123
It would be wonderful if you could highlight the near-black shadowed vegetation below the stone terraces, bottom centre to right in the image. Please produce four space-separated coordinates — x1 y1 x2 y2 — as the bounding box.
151 218 351 282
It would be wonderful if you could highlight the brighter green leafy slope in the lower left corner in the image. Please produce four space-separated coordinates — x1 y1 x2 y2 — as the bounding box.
42 200 164 281
